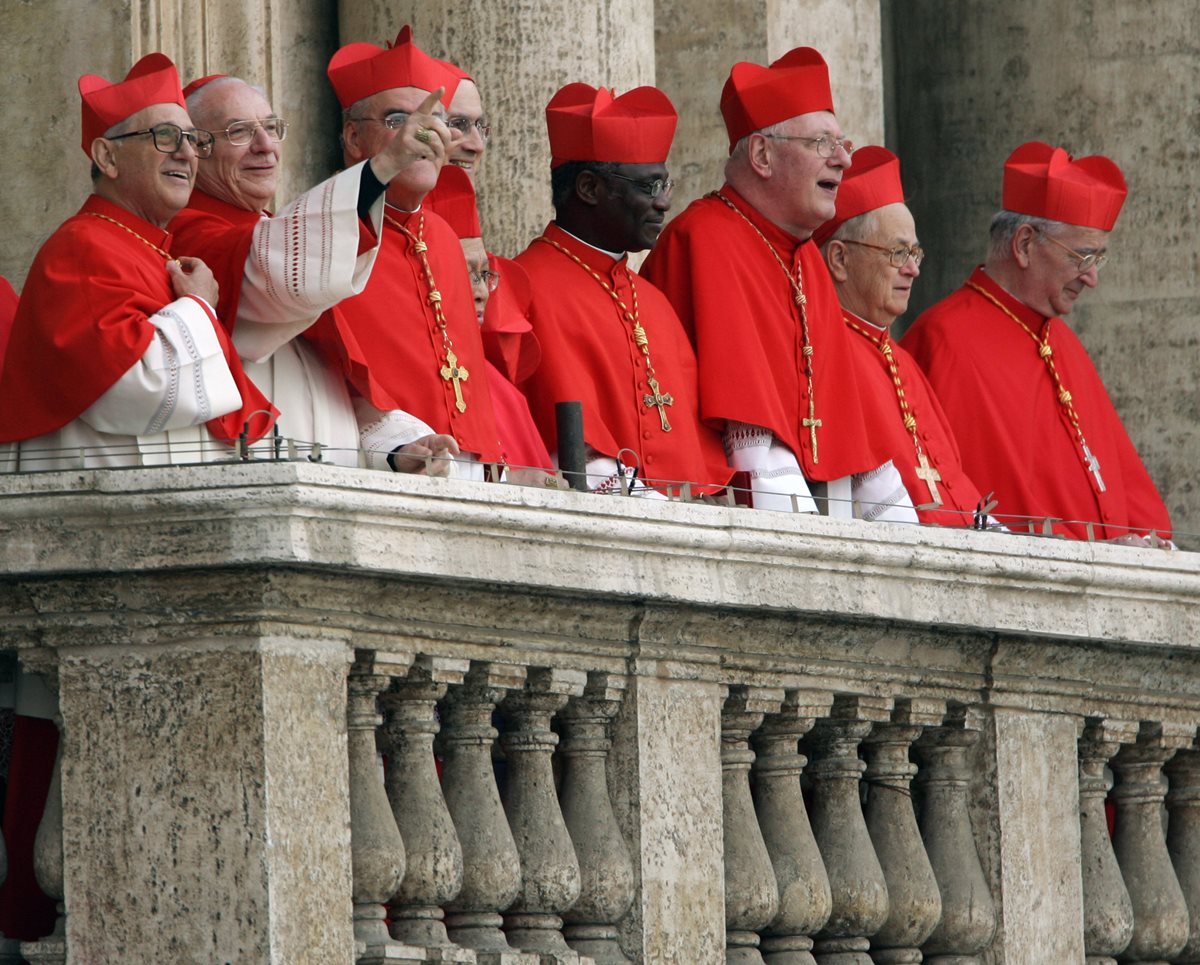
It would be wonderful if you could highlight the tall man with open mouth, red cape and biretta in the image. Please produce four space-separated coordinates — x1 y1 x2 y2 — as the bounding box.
643 47 916 521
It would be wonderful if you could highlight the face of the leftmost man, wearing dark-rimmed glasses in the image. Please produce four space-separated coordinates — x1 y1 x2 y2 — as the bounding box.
104 104 198 228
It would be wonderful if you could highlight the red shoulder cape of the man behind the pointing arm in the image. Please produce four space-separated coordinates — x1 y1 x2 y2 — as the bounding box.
304 208 502 462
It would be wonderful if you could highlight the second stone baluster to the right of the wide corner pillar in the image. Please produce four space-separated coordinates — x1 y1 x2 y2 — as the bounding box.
379 657 475 961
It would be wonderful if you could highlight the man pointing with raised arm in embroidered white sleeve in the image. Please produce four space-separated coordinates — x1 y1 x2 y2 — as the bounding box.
172 76 452 472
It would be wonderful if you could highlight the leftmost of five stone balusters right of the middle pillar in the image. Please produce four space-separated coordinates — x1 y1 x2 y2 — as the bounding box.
721 687 784 965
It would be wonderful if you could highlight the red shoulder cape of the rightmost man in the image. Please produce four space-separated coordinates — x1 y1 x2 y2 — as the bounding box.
904 269 1171 539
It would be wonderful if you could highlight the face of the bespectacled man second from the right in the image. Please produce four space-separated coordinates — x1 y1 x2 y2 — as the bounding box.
829 204 920 328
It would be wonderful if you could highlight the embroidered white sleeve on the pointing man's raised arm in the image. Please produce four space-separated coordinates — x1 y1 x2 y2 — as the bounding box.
233 162 383 361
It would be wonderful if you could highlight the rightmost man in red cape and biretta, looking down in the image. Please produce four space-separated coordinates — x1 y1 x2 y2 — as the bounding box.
902 142 1170 545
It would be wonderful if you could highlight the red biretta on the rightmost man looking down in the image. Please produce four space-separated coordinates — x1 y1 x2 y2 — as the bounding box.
998 140 1129 232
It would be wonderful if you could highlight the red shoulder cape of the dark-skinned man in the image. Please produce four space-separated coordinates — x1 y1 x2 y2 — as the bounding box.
516 224 733 492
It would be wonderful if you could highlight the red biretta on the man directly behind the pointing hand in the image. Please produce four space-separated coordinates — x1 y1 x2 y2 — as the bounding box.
325 24 462 108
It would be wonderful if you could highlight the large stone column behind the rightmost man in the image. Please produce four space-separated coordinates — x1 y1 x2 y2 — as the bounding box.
886 0 1200 542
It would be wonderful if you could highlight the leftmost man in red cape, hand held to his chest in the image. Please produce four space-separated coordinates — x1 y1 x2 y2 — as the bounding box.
0 54 275 469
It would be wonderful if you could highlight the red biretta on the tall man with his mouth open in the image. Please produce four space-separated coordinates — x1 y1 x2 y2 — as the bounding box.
721 47 833 152
